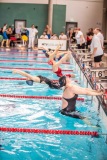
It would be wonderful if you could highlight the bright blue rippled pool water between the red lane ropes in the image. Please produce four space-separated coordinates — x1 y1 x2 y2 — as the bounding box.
0 49 107 160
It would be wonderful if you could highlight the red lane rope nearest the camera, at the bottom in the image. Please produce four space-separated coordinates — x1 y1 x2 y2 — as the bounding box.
0 127 99 137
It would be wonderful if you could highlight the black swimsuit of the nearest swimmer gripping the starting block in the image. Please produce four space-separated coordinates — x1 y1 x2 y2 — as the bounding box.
60 89 84 119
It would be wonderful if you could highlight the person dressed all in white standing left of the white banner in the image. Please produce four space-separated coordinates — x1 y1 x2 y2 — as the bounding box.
25 24 38 48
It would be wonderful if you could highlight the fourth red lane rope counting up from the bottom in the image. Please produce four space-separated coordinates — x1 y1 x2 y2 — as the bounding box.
0 66 73 72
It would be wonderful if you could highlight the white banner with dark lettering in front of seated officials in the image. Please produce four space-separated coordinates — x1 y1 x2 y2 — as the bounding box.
38 39 67 50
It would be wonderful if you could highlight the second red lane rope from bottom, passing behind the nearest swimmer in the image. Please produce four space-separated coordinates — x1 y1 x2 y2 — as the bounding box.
0 94 85 102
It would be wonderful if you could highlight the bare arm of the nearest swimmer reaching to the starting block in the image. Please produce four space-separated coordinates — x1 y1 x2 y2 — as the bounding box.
71 86 104 96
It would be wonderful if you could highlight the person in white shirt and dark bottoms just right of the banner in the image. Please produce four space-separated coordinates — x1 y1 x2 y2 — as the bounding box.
75 28 85 49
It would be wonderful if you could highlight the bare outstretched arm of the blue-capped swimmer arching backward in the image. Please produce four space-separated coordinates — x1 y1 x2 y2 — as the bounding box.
12 69 40 83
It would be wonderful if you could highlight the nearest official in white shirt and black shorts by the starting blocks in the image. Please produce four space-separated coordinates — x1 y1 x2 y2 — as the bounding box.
89 30 103 68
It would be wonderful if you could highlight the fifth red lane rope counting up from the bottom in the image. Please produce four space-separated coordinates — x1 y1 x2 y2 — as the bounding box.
0 60 70 64
